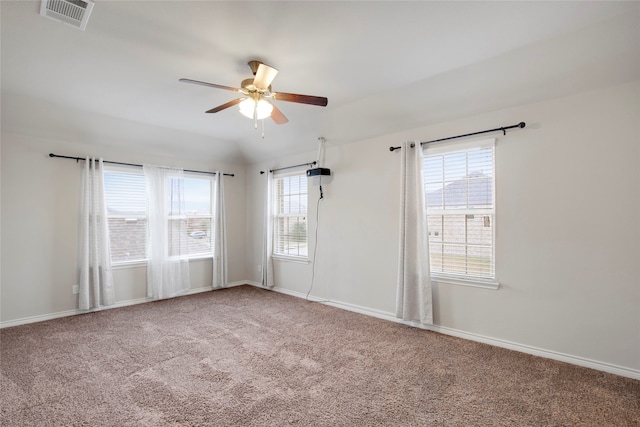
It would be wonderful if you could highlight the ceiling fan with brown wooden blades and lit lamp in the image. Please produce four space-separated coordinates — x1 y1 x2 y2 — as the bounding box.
180 61 328 127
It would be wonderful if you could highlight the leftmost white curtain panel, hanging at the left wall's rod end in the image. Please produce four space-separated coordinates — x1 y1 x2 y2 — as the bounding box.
78 157 115 310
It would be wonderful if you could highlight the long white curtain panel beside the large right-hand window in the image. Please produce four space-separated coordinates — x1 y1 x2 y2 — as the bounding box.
396 142 433 325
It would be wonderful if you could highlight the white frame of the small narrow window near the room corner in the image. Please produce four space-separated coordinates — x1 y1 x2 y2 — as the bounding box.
270 171 310 263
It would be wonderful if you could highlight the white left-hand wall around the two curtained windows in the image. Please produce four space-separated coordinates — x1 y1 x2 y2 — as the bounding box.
0 133 247 322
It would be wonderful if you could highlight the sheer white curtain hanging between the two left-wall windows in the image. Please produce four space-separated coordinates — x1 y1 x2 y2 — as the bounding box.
143 165 190 299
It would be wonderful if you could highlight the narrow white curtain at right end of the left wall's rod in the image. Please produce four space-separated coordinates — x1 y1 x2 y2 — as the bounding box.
212 171 229 289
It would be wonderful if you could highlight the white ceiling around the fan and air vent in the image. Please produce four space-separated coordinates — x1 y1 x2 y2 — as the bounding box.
0 0 640 163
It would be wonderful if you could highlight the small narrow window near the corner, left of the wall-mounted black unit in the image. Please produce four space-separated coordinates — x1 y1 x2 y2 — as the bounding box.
272 173 308 259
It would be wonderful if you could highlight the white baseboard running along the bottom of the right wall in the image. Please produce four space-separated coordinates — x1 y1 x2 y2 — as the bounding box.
264 283 640 380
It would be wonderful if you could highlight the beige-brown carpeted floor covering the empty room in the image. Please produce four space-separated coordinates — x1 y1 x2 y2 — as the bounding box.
0 286 640 427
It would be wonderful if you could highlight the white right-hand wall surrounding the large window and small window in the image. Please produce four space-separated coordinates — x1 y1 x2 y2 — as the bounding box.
247 82 640 375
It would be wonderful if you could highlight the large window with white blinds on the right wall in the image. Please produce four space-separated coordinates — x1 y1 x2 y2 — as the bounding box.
423 140 495 282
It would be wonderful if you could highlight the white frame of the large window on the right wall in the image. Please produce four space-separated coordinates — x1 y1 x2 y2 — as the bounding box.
422 138 500 290
